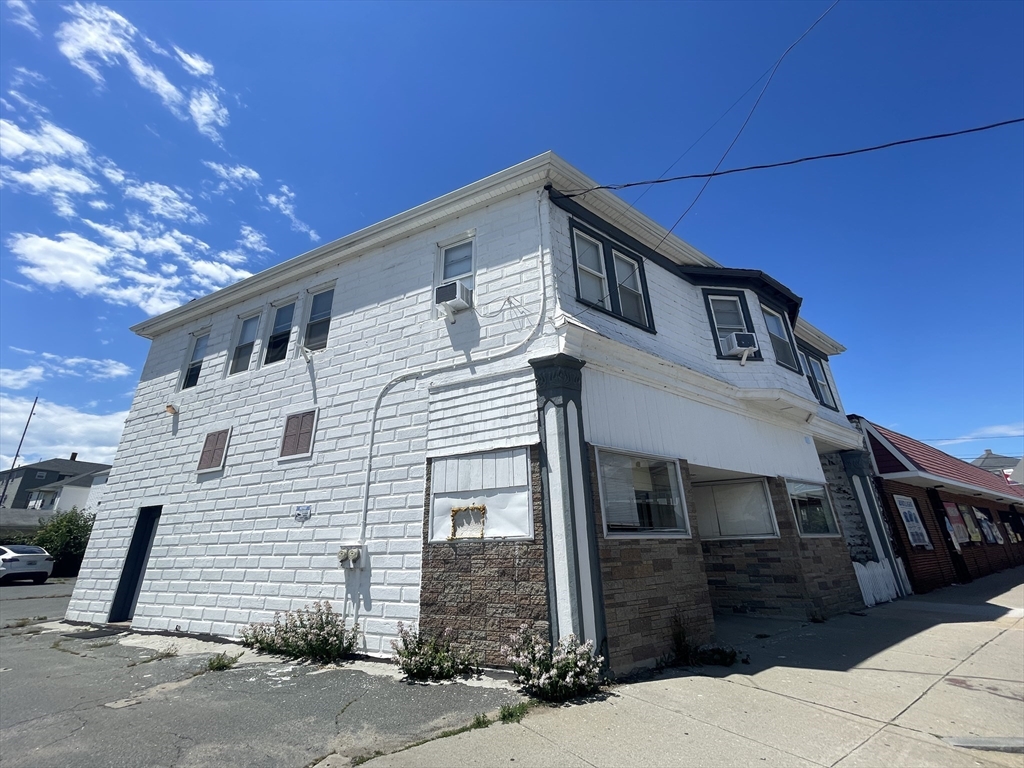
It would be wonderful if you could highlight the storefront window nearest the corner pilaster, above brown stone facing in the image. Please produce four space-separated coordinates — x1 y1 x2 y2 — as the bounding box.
597 449 689 537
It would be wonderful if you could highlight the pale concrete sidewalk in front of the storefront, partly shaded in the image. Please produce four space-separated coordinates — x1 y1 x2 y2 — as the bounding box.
367 567 1024 768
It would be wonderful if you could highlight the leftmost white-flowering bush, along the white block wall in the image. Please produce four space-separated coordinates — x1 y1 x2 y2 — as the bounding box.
242 600 359 664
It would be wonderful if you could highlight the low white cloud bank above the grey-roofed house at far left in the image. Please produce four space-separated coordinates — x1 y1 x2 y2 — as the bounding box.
0 394 128 467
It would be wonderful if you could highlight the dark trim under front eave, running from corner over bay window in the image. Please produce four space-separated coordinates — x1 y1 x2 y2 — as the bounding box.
545 191 803 324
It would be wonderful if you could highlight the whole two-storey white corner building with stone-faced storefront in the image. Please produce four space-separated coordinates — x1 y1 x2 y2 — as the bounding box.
68 153 885 672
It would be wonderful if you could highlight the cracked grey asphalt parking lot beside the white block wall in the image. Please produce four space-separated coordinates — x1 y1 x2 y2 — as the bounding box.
0 588 520 768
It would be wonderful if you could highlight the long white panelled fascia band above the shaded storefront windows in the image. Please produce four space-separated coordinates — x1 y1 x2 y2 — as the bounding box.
583 368 824 482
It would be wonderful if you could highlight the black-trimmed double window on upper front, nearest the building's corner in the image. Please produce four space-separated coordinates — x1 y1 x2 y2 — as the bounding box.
572 224 654 331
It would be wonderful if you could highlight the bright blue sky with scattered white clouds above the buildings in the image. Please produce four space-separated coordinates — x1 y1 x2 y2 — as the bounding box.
0 0 1024 467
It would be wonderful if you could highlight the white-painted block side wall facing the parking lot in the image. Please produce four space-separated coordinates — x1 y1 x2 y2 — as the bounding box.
68 191 556 654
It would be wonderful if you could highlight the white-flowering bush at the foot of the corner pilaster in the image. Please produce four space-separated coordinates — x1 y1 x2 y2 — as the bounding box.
502 624 604 701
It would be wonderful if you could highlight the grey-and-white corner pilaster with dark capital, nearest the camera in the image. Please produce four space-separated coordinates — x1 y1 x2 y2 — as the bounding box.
529 354 606 652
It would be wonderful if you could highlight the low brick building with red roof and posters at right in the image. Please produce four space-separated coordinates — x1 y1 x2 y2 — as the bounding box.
850 416 1024 592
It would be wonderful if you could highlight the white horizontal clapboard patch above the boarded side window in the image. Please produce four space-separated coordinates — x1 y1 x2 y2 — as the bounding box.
427 370 540 456
